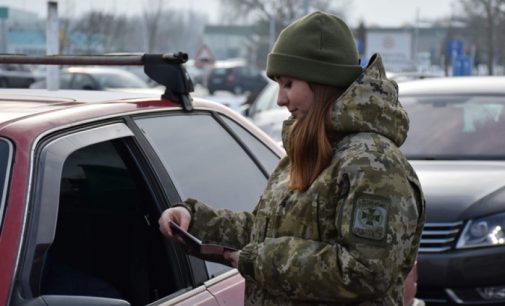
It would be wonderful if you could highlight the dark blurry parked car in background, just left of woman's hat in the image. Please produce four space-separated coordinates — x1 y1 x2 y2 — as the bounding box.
206 63 268 95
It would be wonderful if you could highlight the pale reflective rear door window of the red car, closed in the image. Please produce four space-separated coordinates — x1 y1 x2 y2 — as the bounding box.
136 114 273 210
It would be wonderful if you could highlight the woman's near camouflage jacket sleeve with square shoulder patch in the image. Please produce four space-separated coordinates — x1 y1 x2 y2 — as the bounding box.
239 159 420 302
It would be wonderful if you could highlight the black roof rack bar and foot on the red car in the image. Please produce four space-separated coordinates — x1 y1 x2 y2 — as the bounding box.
0 52 194 111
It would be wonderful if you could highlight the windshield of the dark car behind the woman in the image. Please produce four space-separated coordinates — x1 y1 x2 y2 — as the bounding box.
400 95 505 159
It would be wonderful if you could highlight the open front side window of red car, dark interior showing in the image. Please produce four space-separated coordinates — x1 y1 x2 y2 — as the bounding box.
31 128 185 305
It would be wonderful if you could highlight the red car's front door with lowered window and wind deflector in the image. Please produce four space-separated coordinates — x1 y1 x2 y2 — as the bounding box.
10 122 216 305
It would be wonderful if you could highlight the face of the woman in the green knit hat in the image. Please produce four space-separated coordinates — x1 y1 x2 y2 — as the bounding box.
277 77 314 119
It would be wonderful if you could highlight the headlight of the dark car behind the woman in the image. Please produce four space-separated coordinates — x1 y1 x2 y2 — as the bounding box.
456 213 505 249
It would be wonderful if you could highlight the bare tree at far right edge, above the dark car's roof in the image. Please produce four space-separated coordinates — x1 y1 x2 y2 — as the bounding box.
460 0 505 75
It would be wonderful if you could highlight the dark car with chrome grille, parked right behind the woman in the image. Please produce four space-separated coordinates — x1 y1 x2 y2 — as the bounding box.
399 77 505 305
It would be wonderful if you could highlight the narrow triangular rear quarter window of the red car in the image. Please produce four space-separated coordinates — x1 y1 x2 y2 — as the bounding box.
222 117 279 174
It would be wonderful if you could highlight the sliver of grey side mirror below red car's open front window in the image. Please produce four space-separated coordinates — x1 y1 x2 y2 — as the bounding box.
15 295 131 306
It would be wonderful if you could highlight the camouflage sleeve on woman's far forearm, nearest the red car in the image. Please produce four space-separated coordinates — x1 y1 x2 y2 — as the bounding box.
183 198 253 249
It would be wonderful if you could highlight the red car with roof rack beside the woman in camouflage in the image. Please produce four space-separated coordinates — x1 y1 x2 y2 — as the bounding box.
0 53 415 306
